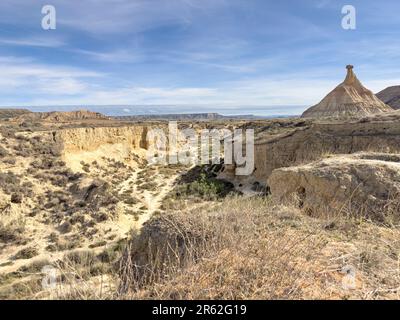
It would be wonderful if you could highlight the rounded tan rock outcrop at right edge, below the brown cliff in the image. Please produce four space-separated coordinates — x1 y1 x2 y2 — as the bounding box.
268 153 400 218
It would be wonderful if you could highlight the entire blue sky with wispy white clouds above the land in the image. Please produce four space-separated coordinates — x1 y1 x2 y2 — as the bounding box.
0 0 400 114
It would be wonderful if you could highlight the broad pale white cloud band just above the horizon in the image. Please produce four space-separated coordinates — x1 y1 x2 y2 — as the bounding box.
0 51 400 112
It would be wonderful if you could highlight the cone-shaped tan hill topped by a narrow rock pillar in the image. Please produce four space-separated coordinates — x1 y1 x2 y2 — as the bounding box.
302 65 393 118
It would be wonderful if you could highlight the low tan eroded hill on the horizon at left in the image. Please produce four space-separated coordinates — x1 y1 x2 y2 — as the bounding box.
16 110 110 122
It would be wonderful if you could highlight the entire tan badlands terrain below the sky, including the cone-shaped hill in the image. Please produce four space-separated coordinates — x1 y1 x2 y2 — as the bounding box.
0 66 400 299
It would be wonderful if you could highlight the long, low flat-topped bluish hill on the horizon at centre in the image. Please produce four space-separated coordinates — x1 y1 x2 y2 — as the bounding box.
114 113 259 121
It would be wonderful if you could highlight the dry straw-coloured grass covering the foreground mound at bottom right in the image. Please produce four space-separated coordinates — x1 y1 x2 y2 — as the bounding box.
119 197 400 299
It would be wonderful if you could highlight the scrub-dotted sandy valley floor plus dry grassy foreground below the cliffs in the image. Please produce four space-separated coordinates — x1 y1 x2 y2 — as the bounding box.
0 120 400 299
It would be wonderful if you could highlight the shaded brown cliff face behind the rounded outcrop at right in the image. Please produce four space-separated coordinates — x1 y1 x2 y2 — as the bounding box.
254 112 400 183
